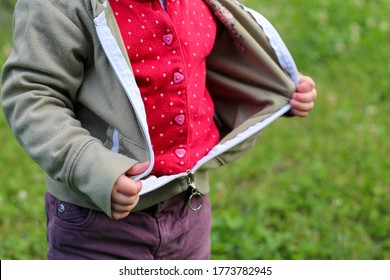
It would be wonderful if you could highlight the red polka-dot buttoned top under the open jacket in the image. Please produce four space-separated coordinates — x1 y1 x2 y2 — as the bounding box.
110 0 219 176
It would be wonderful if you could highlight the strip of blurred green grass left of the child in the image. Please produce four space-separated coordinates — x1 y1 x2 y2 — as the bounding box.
0 0 46 259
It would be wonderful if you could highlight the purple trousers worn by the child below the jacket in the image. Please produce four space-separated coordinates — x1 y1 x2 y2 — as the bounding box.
46 192 211 260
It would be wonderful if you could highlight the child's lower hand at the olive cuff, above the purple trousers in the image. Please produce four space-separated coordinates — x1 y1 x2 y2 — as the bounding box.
111 162 149 220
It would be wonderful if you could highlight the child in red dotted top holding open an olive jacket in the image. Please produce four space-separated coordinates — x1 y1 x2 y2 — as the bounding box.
2 0 316 259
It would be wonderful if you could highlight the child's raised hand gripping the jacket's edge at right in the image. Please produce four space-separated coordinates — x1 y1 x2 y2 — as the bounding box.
290 75 317 117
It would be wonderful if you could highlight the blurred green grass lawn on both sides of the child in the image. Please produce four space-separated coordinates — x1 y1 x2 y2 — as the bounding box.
0 0 390 259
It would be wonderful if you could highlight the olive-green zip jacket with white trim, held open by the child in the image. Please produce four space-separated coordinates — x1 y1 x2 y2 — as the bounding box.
2 0 298 216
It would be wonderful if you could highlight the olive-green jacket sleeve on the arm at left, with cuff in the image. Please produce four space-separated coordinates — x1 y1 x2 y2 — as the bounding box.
2 0 135 215
